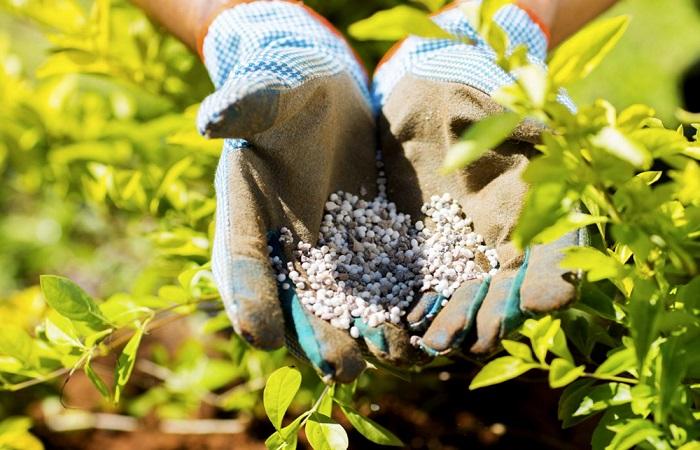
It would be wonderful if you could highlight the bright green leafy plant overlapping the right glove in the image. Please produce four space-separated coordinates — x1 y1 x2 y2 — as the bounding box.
351 0 700 450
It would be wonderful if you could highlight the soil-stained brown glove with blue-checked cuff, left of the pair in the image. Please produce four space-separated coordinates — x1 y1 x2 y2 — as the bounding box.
197 1 410 382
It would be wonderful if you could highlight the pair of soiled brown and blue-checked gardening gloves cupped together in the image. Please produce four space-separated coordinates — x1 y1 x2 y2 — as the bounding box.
198 0 578 382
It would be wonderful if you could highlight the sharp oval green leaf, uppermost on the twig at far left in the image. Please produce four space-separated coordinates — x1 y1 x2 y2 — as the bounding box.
40 275 108 330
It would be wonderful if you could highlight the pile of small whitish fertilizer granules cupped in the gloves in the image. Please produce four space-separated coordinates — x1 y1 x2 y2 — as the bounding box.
268 161 498 338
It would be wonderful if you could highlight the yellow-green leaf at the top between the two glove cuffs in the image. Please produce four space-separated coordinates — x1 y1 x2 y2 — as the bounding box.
348 5 456 41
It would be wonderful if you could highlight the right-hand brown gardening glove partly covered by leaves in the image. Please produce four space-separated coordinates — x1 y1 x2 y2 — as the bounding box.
373 1 581 356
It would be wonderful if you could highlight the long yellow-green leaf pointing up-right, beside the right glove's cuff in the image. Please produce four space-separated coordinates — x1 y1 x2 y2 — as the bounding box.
549 16 629 86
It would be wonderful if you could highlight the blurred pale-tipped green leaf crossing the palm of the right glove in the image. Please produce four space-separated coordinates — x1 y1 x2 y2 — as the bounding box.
442 112 520 173
